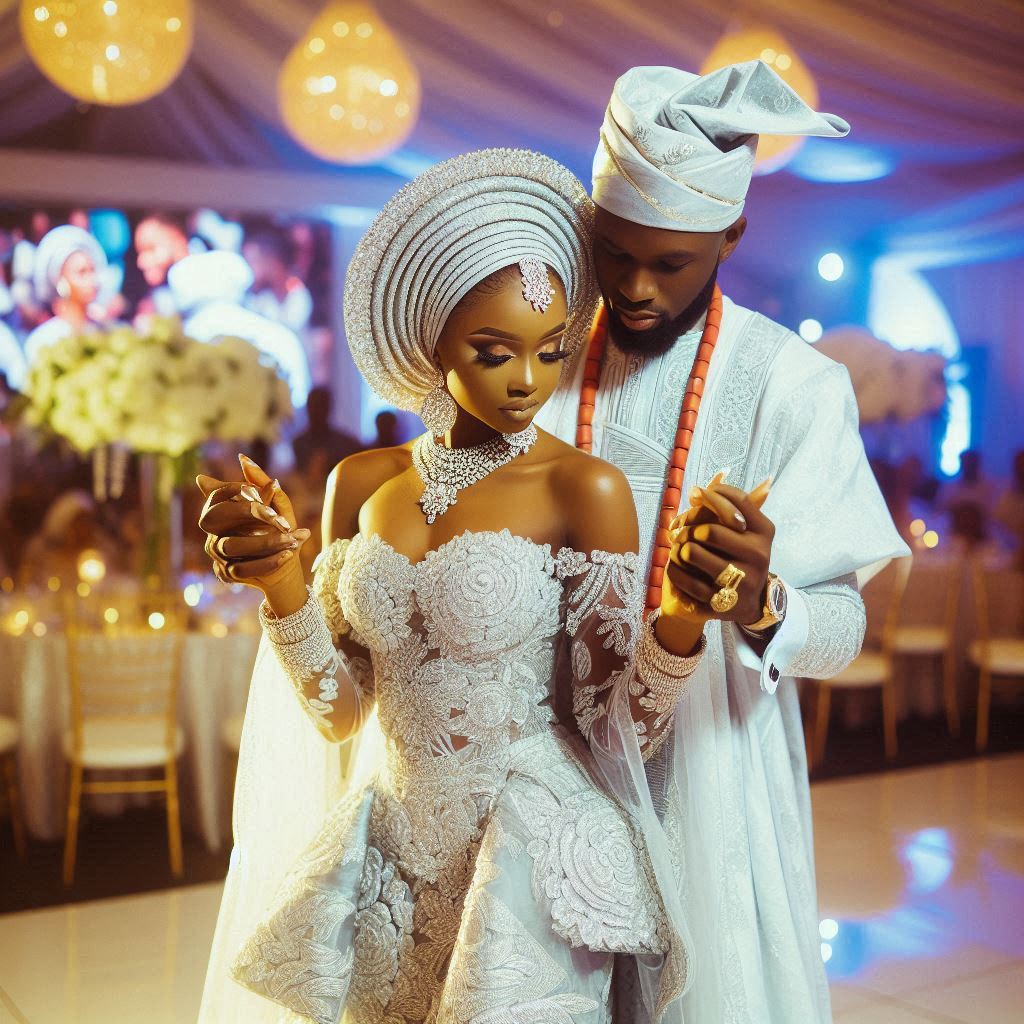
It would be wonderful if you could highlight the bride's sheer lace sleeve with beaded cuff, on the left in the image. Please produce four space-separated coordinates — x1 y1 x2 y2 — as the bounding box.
260 541 374 742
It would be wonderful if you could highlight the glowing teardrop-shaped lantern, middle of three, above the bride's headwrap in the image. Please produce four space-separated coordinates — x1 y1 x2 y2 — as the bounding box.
278 3 420 164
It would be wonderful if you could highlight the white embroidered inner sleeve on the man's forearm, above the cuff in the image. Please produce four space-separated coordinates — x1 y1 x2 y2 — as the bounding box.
786 572 867 679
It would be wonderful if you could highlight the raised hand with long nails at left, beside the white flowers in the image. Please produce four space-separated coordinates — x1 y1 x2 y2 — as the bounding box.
196 456 310 598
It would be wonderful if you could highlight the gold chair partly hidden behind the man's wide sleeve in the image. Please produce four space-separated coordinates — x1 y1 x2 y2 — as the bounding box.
811 558 911 767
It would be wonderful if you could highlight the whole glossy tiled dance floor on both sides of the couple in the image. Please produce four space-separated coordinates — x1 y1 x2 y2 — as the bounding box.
0 756 1024 1024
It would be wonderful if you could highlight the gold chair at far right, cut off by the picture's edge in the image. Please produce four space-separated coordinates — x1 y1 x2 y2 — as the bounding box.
968 557 1024 751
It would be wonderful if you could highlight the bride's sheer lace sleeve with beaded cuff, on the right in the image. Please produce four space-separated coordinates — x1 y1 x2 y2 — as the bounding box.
558 549 703 761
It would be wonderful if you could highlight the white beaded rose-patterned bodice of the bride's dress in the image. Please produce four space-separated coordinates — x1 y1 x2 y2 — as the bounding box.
338 529 589 774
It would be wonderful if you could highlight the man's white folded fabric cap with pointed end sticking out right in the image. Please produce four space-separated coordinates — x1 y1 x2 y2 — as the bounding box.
593 60 850 231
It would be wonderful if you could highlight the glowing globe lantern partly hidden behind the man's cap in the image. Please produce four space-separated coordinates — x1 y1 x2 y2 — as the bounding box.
700 28 818 174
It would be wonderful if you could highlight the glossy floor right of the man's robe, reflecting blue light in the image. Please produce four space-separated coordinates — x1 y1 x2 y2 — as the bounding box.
814 756 1024 1024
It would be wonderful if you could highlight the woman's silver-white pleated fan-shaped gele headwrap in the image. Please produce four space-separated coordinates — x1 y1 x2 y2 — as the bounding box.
345 150 598 412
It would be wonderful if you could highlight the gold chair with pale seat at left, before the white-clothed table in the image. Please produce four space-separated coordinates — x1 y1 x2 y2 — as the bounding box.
63 605 184 885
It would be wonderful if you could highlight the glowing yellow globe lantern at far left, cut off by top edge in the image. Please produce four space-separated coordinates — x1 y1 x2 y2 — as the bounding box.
20 0 193 106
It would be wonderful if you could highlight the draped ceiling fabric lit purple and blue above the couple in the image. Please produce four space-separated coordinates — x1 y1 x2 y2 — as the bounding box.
0 0 1024 460
